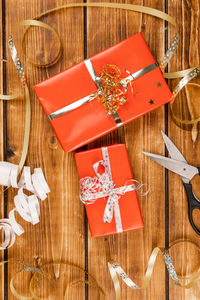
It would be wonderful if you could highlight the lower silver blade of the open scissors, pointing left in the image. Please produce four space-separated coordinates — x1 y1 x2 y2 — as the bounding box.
143 152 198 180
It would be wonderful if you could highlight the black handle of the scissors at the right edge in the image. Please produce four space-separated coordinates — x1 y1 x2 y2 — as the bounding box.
183 182 200 235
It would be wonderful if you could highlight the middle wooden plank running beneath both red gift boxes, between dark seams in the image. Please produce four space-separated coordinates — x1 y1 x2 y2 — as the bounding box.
87 0 165 299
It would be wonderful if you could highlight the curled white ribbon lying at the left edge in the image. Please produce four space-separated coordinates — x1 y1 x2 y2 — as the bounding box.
0 162 50 250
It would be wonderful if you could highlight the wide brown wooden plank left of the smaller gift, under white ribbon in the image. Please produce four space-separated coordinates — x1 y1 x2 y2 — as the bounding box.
6 0 85 299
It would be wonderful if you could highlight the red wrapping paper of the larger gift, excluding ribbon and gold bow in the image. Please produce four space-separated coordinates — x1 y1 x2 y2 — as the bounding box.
34 33 172 152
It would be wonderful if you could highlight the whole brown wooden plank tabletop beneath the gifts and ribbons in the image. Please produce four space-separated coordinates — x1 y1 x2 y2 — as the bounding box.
0 0 200 300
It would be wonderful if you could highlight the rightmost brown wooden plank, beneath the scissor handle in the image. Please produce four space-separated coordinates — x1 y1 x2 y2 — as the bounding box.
169 0 200 300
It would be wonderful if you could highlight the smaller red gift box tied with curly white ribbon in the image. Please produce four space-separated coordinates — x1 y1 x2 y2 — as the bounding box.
75 144 144 237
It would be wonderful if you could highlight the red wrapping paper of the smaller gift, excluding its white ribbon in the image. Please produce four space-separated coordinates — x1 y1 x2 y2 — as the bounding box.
75 144 144 237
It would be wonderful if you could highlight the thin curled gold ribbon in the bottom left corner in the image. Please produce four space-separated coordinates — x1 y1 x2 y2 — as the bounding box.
0 259 105 300
